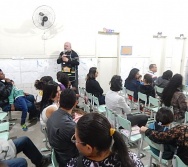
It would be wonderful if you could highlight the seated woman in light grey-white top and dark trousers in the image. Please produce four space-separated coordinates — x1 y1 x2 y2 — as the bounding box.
105 75 148 127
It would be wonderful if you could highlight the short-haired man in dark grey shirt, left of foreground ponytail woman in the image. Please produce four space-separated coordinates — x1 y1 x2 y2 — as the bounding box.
47 89 78 167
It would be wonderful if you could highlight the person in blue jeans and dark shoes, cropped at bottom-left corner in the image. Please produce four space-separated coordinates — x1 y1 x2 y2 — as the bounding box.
0 136 51 167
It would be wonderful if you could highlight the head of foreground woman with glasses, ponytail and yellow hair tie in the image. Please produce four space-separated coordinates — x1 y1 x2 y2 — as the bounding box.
72 113 132 166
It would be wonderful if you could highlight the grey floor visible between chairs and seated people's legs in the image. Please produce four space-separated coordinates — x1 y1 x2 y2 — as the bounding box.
10 111 149 167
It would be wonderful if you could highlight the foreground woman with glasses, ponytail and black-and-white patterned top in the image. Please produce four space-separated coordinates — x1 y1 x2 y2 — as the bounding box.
67 113 143 167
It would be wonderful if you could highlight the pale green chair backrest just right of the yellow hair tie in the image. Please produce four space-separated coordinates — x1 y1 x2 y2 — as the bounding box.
117 115 131 138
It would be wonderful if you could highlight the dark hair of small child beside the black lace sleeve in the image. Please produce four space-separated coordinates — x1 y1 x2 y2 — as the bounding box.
155 107 174 125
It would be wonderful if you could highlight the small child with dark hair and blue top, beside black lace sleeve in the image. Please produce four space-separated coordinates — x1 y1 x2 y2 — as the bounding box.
148 107 176 160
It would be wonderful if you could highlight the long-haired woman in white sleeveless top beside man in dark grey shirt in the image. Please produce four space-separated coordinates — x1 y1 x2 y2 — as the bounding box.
34 81 61 126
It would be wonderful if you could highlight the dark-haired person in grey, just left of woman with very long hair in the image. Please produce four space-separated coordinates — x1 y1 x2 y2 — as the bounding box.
155 70 173 88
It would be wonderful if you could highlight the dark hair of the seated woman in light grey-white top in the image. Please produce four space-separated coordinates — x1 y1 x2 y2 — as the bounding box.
110 75 122 91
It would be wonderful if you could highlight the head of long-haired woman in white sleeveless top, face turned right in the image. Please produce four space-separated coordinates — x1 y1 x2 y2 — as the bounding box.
41 81 61 110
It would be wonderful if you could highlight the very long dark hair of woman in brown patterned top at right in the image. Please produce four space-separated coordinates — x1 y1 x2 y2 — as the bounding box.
161 74 183 107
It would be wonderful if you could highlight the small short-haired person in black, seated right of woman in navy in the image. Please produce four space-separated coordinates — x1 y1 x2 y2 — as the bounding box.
139 74 155 104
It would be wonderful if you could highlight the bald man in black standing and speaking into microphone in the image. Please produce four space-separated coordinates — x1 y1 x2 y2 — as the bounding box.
57 42 79 92
